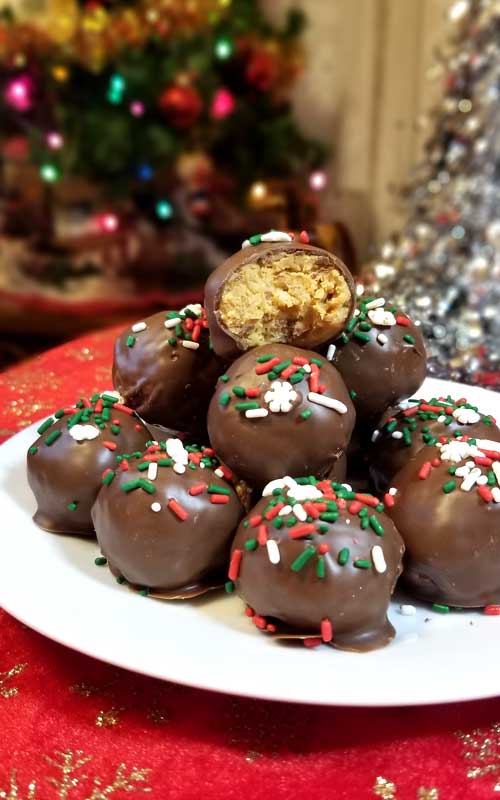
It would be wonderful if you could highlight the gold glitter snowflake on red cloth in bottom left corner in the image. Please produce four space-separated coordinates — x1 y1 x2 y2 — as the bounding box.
0 750 151 800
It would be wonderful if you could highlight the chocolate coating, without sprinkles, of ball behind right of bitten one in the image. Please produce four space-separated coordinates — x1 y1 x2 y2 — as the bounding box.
333 299 427 425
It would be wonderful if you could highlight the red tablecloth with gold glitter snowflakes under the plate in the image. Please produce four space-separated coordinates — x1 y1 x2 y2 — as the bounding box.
0 332 500 800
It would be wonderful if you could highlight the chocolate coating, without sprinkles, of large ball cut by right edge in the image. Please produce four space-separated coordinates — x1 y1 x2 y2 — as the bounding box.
388 447 500 608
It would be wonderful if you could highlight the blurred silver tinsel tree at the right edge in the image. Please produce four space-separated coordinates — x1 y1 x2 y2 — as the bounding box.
368 0 500 390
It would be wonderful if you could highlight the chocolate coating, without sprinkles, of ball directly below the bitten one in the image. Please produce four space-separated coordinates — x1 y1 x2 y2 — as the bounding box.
208 344 355 487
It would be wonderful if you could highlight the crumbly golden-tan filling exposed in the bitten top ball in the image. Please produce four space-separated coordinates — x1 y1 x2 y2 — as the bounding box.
219 252 351 349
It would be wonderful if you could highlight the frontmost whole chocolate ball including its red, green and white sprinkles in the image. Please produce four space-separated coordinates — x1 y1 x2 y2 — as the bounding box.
226 478 404 651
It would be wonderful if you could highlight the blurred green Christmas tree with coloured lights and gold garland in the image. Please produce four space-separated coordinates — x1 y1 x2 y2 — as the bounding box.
0 0 326 296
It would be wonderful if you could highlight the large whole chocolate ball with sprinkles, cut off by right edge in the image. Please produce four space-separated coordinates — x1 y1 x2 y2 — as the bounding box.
388 439 500 608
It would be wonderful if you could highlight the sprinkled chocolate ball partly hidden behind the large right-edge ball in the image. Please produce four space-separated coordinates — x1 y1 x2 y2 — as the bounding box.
368 395 500 493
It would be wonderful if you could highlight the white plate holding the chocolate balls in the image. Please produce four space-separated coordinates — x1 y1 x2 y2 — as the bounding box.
0 379 500 706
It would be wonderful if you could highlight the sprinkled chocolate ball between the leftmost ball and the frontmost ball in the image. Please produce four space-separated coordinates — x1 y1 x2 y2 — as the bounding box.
92 439 243 597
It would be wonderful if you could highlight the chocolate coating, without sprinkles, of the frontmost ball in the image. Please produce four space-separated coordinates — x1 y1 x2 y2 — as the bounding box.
233 482 404 651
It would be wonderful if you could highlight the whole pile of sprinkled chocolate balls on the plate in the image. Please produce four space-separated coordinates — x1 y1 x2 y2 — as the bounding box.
28 231 500 651
